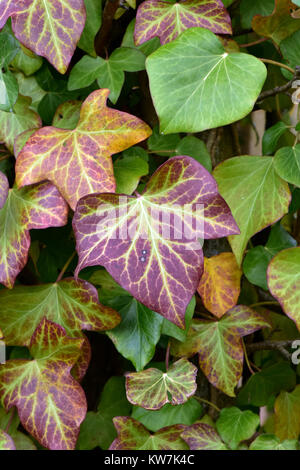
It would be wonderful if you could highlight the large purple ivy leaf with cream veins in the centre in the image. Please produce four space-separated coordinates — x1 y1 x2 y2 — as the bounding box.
73 157 238 328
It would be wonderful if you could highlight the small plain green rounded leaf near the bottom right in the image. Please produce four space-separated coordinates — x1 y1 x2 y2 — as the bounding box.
216 406 260 450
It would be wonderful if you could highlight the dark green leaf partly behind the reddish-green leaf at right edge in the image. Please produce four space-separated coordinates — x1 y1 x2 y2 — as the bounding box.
243 224 297 290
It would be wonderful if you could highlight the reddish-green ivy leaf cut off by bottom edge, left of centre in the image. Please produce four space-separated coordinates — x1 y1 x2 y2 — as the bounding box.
109 416 188 450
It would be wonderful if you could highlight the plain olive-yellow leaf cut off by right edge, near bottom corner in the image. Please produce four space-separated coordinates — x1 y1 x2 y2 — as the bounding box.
274 385 300 441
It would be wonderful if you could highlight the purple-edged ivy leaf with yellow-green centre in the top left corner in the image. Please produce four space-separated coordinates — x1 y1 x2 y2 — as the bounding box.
0 0 86 73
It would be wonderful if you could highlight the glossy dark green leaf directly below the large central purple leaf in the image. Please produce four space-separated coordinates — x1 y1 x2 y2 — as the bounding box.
107 295 163 371
